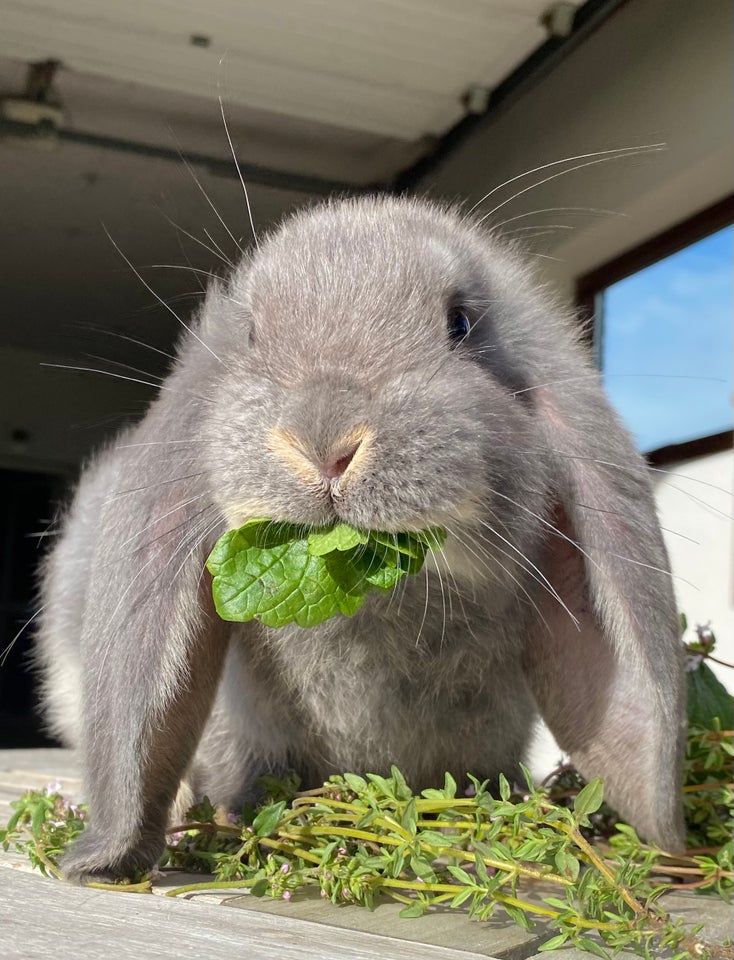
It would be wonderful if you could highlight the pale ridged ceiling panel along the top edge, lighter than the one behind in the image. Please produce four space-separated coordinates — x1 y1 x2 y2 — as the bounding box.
0 0 568 140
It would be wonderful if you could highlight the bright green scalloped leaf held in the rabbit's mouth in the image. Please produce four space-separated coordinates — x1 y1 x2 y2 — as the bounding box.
206 518 446 627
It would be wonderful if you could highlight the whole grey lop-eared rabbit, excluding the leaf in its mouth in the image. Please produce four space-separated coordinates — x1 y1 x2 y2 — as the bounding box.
37 196 684 882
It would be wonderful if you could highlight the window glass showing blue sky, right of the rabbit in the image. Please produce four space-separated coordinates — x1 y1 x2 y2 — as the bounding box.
597 227 734 451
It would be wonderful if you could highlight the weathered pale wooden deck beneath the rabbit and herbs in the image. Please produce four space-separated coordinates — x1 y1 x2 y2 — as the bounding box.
0 750 731 960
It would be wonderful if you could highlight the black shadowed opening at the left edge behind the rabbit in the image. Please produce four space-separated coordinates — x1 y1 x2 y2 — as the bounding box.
0 470 65 748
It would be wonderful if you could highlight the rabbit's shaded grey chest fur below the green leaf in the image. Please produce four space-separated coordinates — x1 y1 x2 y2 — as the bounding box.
221 574 534 787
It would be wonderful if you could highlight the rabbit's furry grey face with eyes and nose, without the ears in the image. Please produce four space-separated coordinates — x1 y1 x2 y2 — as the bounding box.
201 200 545 556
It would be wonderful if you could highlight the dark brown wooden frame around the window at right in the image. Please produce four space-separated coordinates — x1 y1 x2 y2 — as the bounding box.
576 194 734 465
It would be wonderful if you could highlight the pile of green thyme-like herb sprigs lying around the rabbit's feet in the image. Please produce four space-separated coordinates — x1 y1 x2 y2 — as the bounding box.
0 627 734 960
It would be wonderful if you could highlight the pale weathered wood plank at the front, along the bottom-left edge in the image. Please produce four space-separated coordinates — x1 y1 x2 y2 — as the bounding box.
0 870 494 960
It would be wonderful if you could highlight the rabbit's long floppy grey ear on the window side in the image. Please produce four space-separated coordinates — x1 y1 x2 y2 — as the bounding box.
525 378 685 851
